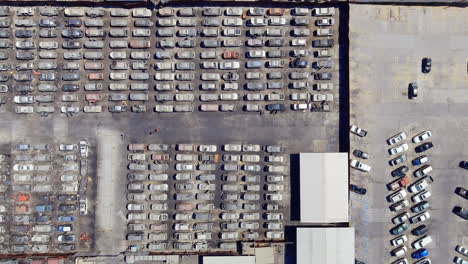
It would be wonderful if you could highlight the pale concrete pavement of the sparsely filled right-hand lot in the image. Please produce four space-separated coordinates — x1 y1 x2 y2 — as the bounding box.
350 5 468 263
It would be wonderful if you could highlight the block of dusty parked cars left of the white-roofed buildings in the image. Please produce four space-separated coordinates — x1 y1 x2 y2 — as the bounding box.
127 144 289 251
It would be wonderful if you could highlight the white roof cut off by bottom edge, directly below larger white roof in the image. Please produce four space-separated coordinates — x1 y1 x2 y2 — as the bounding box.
296 227 354 264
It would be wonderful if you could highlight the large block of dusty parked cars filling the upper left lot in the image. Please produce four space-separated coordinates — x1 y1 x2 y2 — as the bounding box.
0 7 340 116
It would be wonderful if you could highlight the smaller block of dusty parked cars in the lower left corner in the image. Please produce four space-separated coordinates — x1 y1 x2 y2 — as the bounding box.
0 141 89 253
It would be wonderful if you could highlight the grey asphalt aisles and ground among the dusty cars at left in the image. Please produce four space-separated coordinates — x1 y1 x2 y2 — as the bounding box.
0 2 346 255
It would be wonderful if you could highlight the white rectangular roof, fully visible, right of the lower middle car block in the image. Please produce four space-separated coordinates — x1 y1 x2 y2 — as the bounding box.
299 153 349 223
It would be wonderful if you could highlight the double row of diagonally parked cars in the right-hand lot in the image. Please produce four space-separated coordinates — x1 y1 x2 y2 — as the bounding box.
387 131 433 264
